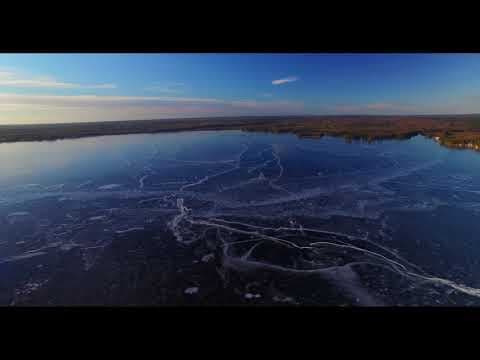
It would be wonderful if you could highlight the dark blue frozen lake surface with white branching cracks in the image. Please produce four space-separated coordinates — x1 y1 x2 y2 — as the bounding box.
0 131 480 306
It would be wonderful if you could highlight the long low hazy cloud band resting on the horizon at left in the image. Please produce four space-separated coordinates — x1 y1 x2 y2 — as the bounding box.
0 94 304 124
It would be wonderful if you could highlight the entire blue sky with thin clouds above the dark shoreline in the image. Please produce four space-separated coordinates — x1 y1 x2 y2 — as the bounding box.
0 54 480 124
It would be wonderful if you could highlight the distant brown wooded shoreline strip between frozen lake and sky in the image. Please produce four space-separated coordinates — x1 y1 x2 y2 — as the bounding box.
0 115 480 150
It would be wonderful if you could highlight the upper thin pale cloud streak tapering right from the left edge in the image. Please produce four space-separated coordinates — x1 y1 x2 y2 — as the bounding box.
0 71 116 89
